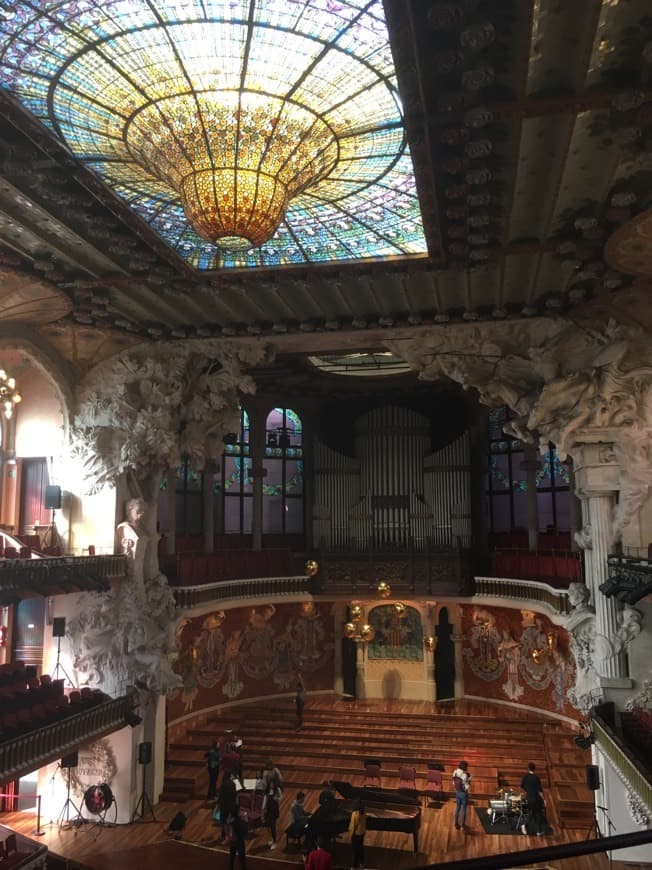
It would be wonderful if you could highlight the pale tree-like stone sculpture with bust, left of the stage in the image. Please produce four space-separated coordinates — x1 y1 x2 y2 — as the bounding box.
69 342 265 695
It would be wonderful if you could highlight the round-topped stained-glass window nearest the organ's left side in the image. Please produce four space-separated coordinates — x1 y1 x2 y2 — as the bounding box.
263 408 303 534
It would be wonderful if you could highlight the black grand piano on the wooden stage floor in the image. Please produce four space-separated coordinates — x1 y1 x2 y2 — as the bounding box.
306 780 421 852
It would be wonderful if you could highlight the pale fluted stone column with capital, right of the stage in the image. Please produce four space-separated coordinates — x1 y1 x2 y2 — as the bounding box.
573 442 627 686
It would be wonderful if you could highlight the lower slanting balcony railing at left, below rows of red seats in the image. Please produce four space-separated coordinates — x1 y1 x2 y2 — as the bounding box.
0 695 133 783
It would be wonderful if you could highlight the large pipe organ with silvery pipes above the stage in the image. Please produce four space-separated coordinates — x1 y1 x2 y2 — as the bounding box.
313 406 471 551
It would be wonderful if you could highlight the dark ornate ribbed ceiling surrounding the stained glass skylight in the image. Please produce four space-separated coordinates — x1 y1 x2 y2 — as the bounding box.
0 0 652 376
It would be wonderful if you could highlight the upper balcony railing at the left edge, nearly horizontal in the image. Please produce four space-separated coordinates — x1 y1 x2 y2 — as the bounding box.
0 556 126 605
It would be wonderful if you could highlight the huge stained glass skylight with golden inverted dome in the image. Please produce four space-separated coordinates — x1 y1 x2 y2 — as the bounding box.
0 0 427 270
